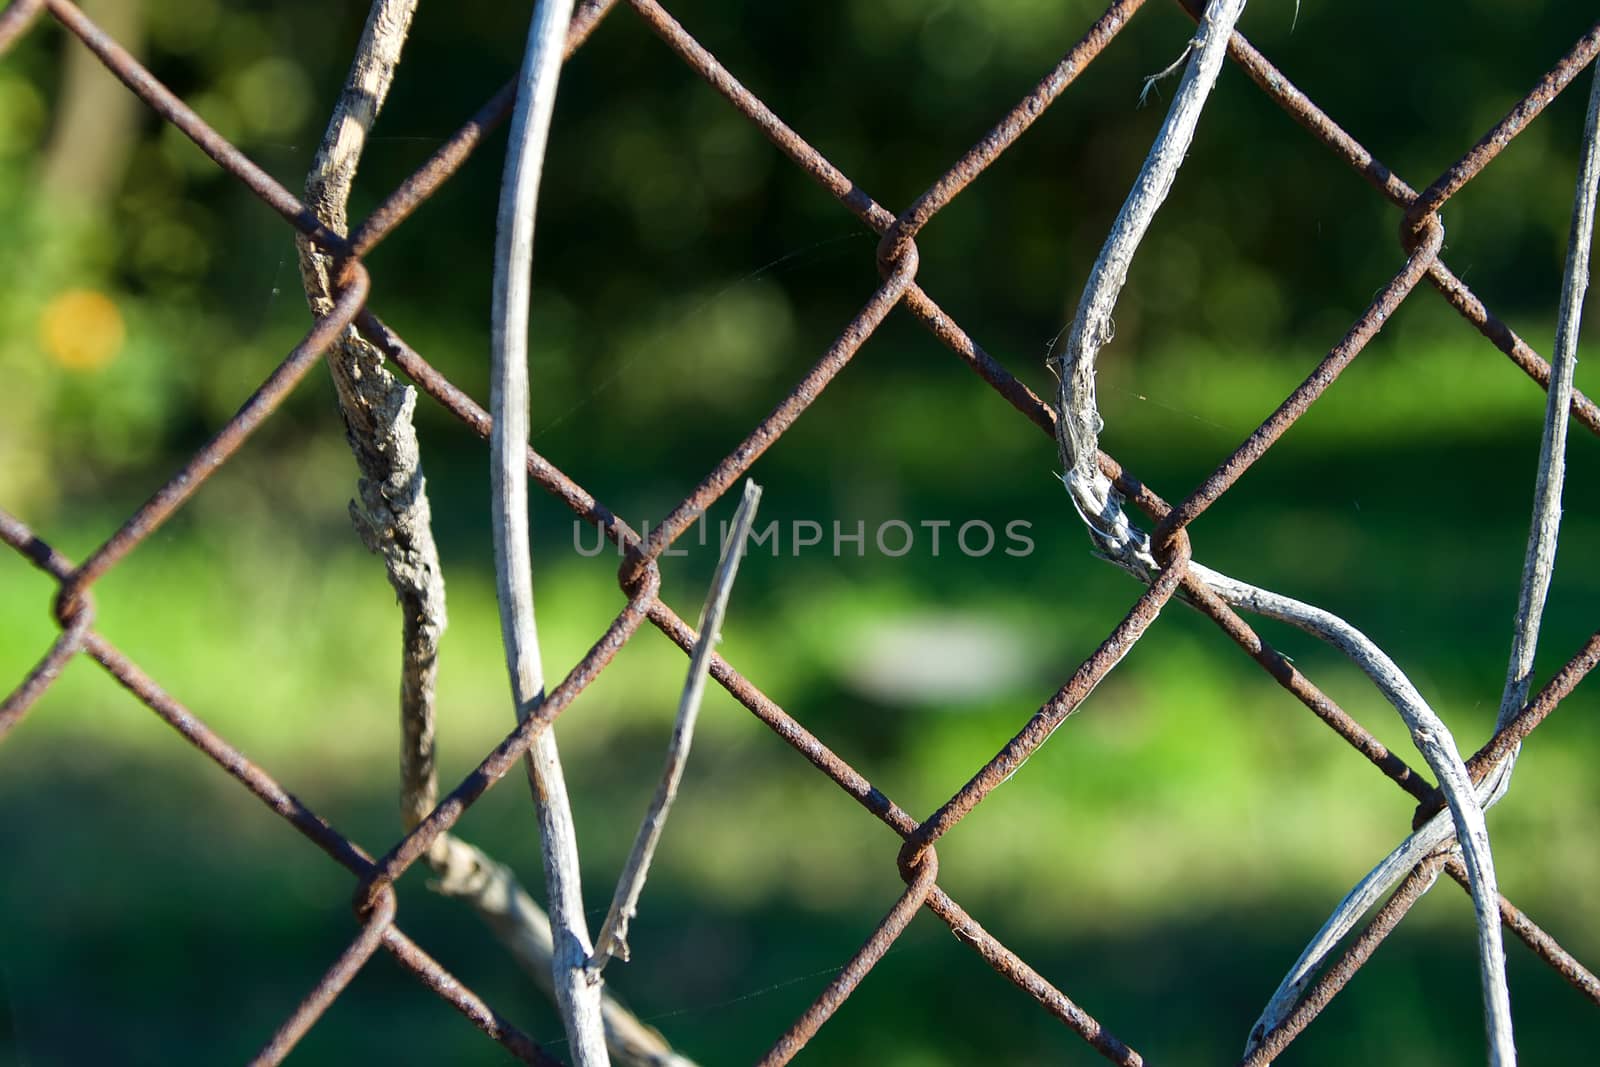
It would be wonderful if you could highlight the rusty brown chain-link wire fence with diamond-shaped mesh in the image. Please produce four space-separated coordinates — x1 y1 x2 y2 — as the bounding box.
0 0 1600 1064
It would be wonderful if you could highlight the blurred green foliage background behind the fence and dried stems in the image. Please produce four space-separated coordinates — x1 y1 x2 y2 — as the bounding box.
0 0 1600 1067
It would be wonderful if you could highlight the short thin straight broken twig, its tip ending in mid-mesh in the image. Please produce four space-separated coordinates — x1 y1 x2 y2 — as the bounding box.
589 480 762 973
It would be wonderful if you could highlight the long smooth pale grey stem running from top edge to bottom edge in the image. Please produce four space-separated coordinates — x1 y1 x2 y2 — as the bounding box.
490 0 610 1067
